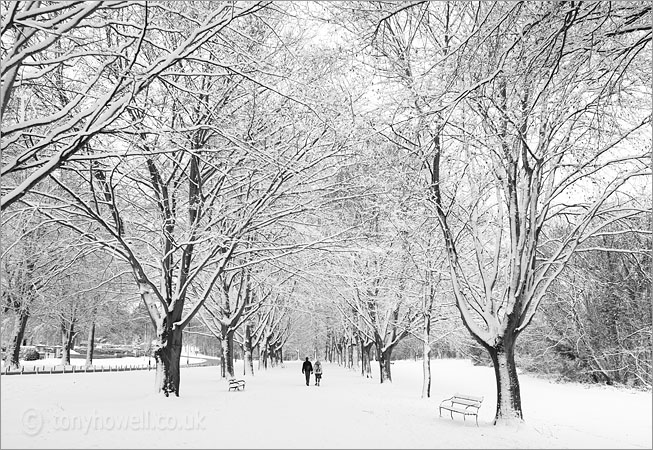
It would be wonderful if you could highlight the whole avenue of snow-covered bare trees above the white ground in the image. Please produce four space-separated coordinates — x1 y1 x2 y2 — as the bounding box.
0 1 653 423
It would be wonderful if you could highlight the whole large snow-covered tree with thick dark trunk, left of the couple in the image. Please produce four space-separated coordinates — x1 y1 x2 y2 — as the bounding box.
6 3 341 395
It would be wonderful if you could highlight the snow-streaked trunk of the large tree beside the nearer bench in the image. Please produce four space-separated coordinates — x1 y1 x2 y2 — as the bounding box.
486 340 524 425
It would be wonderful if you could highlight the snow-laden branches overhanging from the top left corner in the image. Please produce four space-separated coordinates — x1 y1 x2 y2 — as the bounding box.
0 1 265 210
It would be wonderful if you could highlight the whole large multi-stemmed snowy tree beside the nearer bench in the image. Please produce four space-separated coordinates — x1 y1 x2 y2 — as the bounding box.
350 2 651 423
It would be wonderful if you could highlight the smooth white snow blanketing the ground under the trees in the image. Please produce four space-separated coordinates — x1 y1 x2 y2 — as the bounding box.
0 360 653 448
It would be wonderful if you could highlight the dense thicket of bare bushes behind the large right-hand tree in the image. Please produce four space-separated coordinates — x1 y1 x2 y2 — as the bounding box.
522 218 652 387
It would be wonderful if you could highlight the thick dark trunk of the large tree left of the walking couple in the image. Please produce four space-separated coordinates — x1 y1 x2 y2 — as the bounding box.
154 325 183 397
